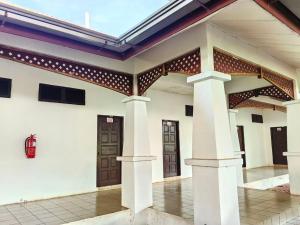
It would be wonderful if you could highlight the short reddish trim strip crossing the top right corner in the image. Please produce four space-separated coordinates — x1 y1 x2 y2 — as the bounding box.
254 0 300 34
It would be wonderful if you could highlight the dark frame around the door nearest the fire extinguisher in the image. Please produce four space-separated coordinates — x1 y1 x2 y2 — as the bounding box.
96 114 124 188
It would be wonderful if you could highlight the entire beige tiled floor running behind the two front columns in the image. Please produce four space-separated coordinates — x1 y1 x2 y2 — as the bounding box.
0 168 300 225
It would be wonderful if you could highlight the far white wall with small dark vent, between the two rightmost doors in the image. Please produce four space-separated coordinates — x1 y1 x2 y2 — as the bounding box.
237 109 286 168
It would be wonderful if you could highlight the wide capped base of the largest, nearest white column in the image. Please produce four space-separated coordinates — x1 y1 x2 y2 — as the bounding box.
185 159 242 225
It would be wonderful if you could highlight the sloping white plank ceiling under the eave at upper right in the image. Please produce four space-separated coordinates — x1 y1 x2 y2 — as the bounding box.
210 0 300 68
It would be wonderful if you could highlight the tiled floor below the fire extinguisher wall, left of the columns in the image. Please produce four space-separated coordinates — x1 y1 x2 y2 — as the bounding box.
0 189 124 225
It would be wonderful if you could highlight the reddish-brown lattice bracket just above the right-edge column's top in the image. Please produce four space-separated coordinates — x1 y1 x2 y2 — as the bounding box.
261 69 294 98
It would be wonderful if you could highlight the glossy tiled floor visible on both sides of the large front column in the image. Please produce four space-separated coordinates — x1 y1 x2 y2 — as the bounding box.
154 179 300 225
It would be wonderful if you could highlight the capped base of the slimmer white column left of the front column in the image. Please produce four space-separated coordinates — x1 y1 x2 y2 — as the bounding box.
117 156 156 213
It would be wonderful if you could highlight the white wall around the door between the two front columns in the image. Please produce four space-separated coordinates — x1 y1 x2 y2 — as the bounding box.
147 91 193 181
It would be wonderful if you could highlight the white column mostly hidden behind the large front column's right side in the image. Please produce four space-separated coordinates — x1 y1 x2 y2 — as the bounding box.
229 109 245 187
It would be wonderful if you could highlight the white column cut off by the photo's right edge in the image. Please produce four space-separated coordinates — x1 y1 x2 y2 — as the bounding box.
284 100 300 195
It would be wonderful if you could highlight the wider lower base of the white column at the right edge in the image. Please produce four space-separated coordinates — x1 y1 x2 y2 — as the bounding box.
283 152 300 195
